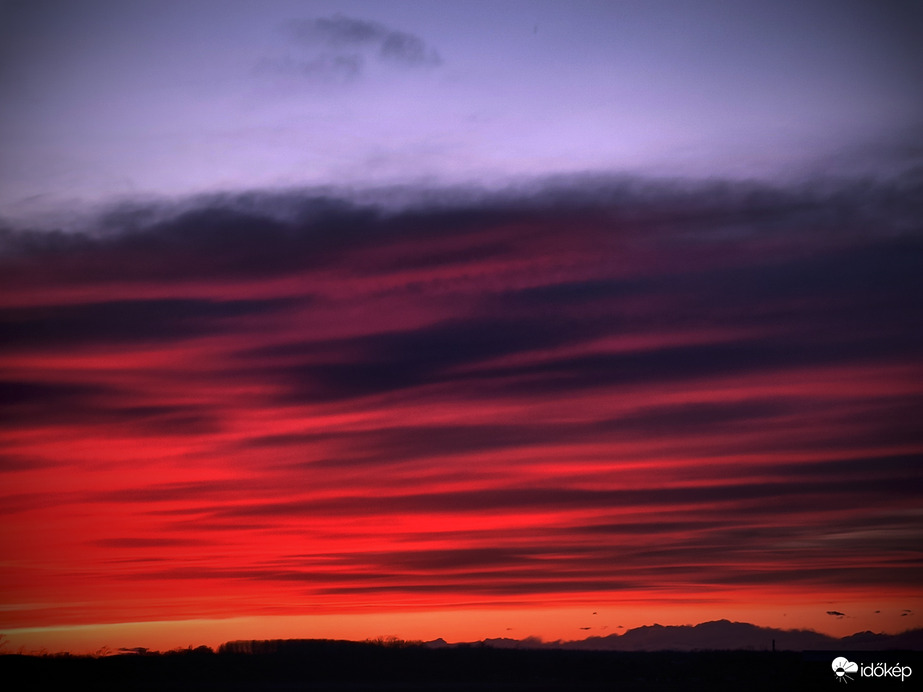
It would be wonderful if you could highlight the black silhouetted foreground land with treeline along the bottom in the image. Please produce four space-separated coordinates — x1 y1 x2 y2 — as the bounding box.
0 641 923 692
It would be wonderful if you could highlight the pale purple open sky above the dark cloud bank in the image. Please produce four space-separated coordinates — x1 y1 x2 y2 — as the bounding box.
0 0 923 219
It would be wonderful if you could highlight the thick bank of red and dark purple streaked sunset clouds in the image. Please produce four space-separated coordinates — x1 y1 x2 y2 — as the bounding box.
0 174 923 627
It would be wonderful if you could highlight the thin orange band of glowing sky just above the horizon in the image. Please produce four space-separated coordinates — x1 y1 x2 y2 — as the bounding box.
4 594 923 654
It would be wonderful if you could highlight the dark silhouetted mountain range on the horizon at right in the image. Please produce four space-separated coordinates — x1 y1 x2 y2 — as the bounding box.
425 620 923 651
